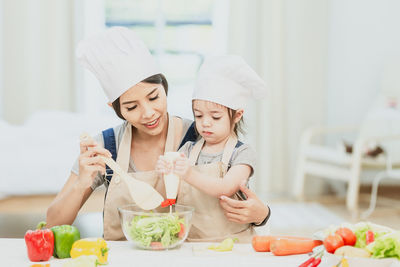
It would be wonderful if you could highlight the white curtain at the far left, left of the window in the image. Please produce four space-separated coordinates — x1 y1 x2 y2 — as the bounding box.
0 0 75 123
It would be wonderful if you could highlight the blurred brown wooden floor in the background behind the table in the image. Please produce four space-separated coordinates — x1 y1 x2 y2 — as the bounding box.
0 187 400 238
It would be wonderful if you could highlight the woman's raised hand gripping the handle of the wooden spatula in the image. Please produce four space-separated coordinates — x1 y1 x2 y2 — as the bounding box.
78 139 111 188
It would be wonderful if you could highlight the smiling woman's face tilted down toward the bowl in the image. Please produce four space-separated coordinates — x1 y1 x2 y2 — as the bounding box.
120 82 167 135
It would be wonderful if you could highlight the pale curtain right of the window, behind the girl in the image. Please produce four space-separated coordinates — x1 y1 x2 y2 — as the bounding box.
228 0 328 196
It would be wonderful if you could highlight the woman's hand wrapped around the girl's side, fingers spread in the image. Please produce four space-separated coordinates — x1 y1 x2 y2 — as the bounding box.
219 184 269 224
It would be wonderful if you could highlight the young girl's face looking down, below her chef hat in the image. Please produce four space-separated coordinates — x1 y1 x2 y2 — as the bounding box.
193 100 232 144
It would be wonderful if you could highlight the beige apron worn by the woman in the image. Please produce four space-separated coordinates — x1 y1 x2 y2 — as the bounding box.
103 116 182 240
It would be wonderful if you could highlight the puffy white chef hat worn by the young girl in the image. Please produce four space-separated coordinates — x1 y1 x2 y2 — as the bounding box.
192 55 267 110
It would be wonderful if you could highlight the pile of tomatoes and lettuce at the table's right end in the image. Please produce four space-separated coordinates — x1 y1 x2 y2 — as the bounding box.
318 222 400 260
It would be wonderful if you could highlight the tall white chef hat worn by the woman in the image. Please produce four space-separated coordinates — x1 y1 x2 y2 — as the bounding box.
76 27 160 102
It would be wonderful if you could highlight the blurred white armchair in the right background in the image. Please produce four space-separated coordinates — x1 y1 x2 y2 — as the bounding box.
294 100 400 214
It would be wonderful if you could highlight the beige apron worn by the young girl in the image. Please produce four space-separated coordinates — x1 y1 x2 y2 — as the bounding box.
177 137 254 243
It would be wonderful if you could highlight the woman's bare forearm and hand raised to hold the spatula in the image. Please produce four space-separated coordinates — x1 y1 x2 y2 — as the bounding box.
46 140 111 227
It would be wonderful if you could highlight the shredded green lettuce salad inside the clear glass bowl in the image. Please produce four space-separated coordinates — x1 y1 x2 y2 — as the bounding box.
126 214 185 249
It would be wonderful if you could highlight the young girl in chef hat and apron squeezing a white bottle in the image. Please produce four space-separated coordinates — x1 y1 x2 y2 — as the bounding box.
156 56 266 242
